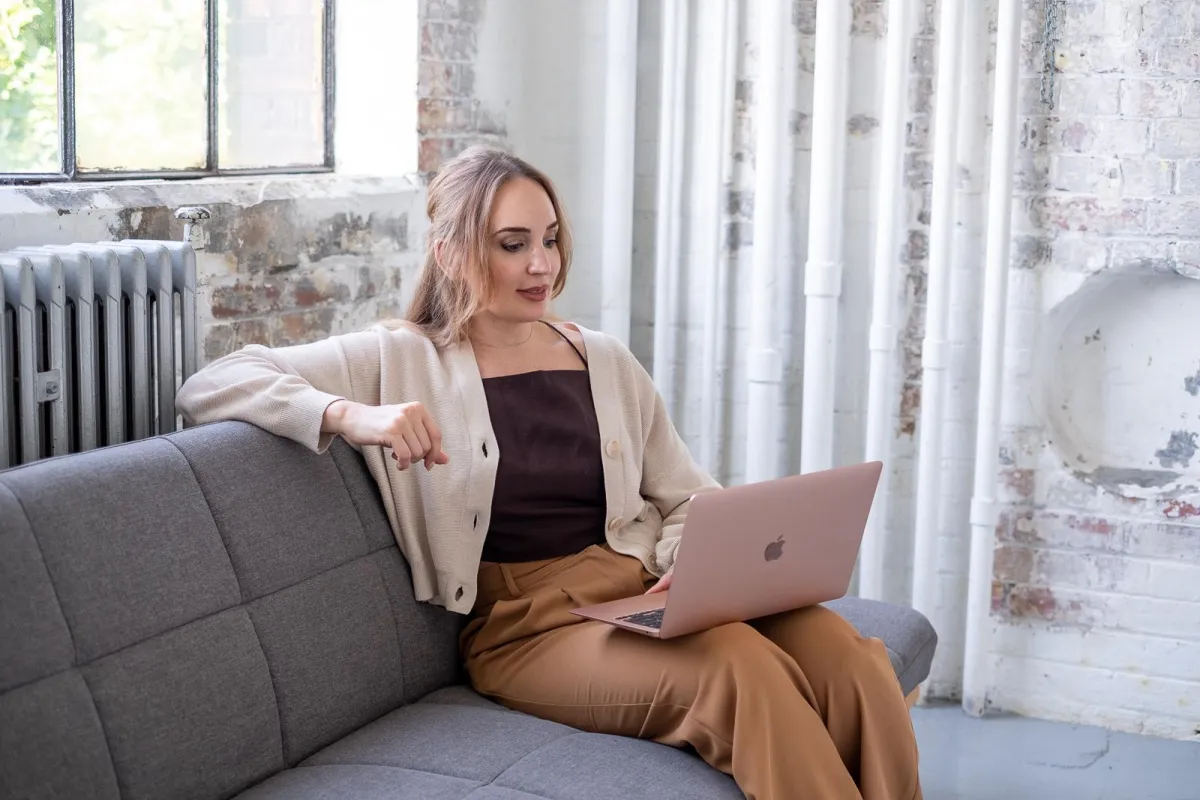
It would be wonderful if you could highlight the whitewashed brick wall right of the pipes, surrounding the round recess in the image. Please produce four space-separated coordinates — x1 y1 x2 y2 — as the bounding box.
992 0 1200 738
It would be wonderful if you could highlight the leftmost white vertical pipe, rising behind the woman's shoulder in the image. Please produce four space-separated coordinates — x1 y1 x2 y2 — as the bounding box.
600 0 637 345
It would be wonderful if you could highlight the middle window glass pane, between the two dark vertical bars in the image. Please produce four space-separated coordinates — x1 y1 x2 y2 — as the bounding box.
72 0 208 170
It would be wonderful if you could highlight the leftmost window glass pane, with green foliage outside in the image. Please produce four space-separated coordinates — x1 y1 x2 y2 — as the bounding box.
0 0 62 173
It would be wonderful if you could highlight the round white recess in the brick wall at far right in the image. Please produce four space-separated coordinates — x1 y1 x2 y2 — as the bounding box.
1033 269 1200 499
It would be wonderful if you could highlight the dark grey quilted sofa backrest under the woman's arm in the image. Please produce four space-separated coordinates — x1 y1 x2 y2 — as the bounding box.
0 422 461 799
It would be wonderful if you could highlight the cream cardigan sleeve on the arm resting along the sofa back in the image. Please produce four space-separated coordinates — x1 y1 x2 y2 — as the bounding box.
175 331 380 453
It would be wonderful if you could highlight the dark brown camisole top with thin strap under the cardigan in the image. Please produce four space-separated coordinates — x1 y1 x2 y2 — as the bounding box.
482 324 606 563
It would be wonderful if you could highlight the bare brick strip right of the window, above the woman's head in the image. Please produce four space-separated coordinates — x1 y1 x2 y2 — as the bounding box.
416 0 506 175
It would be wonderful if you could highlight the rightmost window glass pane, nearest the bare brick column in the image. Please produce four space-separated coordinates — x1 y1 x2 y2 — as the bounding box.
217 0 325 169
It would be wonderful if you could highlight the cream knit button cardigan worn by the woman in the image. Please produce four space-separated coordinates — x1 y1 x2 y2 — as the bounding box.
176 326 718 614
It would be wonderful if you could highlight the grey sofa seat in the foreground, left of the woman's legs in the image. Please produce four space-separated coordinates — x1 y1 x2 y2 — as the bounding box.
238 686 743 800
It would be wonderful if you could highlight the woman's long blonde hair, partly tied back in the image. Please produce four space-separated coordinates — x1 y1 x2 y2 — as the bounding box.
396 146 571 347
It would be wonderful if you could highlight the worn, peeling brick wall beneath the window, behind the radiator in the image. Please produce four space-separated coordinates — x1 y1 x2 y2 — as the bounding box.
0 176 422 362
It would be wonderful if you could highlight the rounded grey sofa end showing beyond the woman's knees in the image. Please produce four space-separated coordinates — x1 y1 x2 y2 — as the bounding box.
826 597 937 694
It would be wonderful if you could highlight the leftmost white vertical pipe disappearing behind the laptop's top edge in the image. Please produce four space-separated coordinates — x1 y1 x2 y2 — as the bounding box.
745 2 796 483
